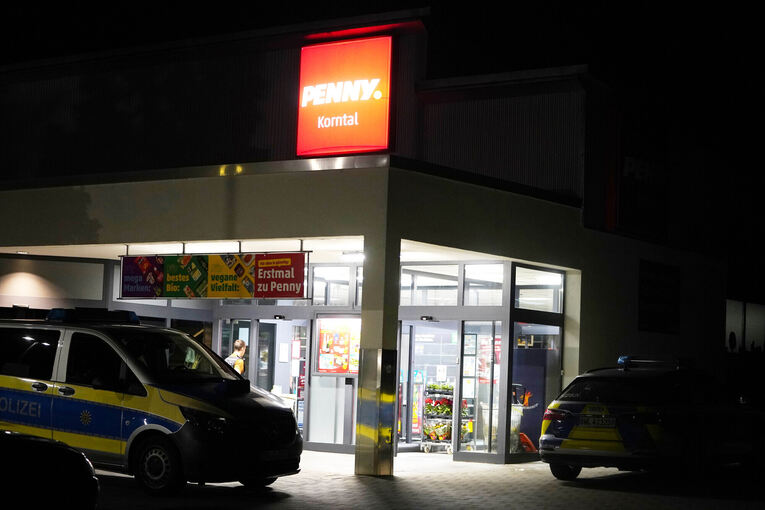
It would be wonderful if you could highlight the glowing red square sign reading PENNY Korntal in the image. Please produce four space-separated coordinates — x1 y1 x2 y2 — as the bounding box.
297 36 392 156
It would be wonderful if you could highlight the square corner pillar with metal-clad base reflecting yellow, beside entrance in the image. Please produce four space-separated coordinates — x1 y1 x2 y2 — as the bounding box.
355 227 401 476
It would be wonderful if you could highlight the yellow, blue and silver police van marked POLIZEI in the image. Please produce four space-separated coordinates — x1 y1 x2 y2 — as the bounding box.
0 309 303 494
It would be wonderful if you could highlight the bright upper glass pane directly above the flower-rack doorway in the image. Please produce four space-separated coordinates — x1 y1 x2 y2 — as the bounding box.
400 265 459 306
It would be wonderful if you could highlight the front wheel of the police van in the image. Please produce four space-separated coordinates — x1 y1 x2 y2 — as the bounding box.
135 436 186 496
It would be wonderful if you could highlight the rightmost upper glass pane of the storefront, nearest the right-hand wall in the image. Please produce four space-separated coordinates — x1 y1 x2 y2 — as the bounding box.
515 267 563 313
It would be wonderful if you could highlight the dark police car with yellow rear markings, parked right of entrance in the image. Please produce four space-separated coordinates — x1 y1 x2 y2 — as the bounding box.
539 356 765 480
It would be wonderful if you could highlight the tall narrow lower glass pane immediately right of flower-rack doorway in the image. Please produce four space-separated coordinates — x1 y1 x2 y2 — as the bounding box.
459 322 502 453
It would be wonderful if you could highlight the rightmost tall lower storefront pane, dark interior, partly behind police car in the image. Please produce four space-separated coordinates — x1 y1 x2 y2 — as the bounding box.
508 322 561 453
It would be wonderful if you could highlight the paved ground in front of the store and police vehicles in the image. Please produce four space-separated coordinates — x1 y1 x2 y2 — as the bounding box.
98 451 765 510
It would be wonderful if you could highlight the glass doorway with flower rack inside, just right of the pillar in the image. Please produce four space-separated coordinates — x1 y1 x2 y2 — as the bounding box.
399 321 460 452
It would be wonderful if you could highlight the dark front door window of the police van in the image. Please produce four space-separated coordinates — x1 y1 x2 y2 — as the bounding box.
66 333 122 391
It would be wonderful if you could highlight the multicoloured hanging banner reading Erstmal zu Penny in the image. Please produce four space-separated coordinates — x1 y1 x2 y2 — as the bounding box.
120 252 306 299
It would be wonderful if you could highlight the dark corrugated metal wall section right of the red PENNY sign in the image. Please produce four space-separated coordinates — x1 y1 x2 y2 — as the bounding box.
423 91 585 198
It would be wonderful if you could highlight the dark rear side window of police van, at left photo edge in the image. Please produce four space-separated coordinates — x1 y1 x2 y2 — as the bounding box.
0 328 61 380
